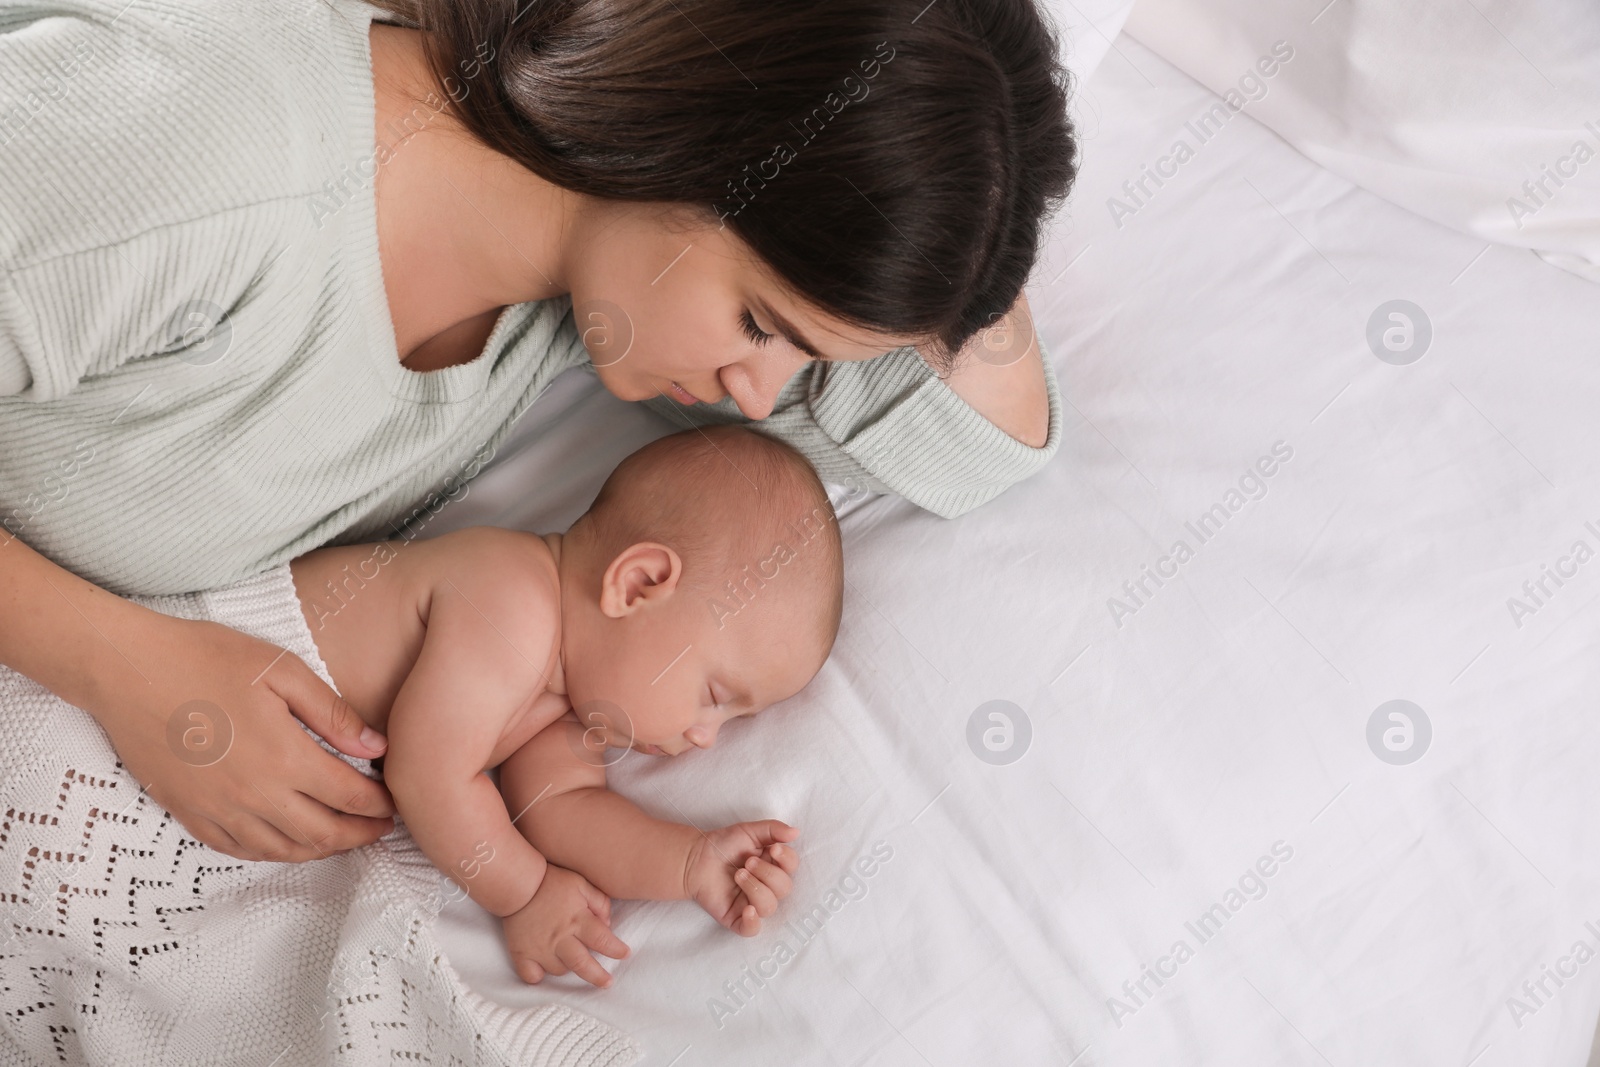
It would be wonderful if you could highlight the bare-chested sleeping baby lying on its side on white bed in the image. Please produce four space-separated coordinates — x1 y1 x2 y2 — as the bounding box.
291 426 843 987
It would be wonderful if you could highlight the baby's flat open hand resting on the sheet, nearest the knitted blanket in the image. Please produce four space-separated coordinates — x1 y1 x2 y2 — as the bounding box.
501 864 627 989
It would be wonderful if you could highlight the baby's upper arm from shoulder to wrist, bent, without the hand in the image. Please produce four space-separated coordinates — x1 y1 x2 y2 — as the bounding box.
384 558 557 917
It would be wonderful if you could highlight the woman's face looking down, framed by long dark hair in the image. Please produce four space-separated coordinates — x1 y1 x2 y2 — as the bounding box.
566 202 915 419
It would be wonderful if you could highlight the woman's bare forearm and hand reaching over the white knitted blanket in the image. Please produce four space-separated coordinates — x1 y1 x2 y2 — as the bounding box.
0 530 394 862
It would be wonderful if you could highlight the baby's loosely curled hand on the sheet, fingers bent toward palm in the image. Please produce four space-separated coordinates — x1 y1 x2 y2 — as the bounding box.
683 819 800 937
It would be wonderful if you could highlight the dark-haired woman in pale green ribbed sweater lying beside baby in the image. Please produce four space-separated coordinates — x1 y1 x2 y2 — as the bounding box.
0 0 1075 861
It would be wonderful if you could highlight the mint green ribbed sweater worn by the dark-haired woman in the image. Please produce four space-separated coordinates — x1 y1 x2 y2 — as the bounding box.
0 0 1061 595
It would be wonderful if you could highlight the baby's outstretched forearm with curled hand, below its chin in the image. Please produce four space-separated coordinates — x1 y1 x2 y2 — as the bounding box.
499 718 798 936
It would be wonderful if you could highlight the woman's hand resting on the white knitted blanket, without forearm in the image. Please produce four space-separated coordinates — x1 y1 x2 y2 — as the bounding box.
98 613 394 862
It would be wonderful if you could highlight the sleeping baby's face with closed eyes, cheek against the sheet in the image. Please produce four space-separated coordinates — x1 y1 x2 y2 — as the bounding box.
562 545 822 755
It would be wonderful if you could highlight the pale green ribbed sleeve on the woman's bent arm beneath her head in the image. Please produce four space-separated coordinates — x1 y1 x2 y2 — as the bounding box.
643 339 1061 518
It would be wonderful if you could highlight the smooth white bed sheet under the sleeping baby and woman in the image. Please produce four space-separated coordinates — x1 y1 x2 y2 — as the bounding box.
422 37 1600 1067
